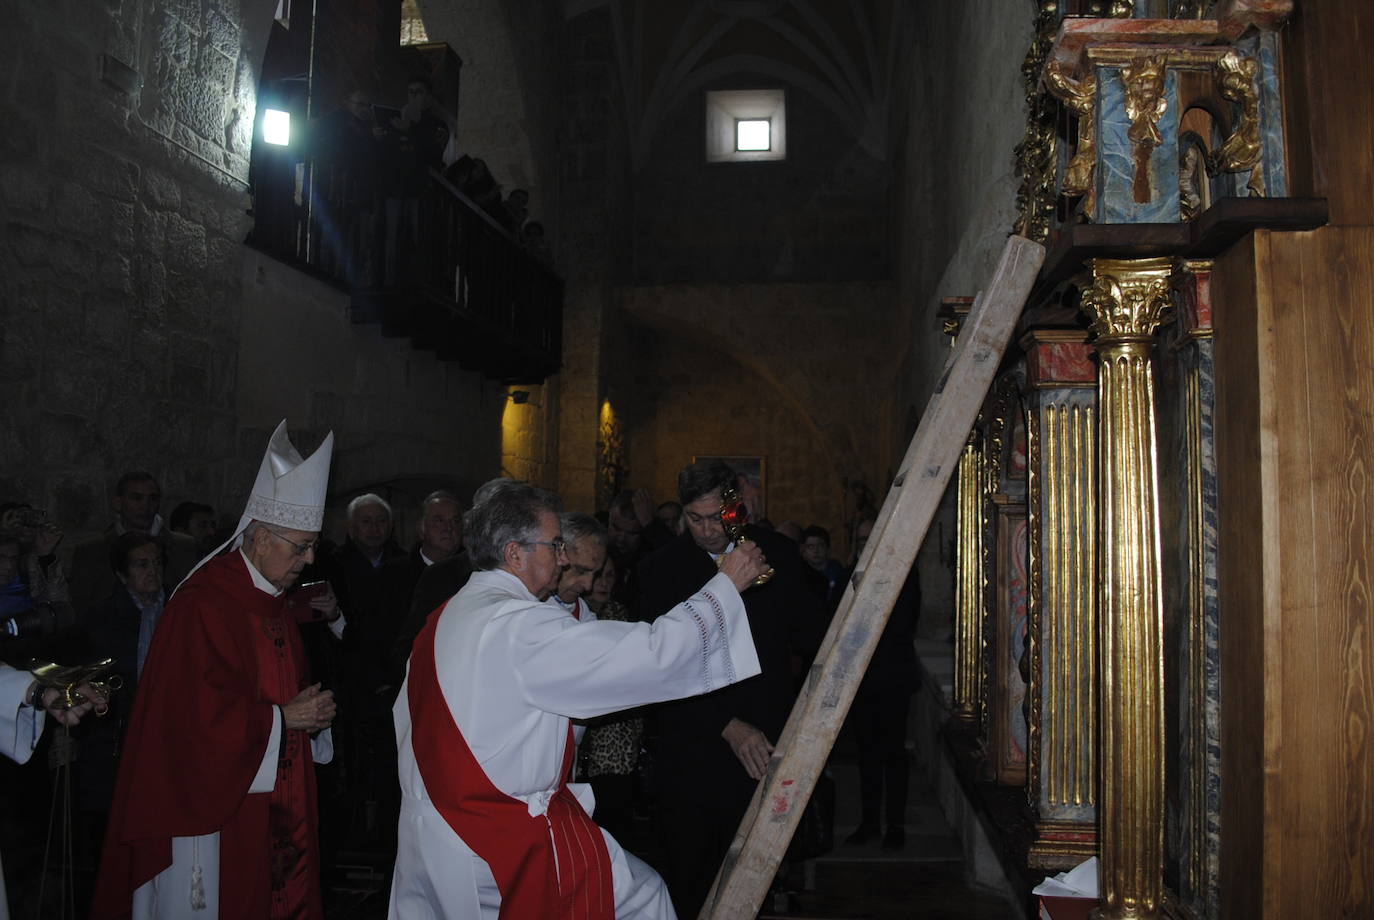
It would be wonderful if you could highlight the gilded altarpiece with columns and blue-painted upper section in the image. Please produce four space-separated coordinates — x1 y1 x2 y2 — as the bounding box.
988 0 1297 920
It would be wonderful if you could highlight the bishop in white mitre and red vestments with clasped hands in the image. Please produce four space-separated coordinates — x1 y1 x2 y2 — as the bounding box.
91 422 337 920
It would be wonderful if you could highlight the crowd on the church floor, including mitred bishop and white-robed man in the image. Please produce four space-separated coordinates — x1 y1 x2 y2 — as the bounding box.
0 423 919 919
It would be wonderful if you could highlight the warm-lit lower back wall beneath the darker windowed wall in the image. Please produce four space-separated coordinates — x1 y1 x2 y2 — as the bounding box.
609 283 894 559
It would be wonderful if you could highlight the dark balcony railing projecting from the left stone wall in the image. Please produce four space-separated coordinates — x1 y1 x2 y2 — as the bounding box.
249 154 563 383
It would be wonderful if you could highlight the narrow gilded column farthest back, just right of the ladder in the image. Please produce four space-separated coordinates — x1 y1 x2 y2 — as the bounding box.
954 427 984 725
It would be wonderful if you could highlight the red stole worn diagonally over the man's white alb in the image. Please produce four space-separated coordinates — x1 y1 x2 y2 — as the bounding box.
407 617 616 920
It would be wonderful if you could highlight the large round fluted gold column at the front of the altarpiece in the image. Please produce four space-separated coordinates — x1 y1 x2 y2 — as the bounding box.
1083 258 1172 920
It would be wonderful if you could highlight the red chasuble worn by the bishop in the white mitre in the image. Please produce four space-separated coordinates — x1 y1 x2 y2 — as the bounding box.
91 552 323 920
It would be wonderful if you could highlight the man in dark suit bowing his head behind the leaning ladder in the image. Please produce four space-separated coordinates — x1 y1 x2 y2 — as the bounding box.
638 460 823 917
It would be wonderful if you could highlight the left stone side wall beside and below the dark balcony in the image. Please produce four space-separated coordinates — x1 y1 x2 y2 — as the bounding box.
0 0 558 545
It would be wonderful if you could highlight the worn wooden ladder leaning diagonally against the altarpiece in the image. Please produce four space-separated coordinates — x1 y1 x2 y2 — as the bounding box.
701 236 1044 920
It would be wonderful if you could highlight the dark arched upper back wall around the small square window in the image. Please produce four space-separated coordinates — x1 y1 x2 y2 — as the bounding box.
632 77 892 284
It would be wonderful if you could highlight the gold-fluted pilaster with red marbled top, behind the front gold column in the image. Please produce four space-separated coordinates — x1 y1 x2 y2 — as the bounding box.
1021 330 1098 872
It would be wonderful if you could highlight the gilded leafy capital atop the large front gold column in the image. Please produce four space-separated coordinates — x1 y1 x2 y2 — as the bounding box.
1083 258 1173 349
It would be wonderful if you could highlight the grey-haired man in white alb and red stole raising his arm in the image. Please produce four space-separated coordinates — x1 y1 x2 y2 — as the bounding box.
390 481 767 920
